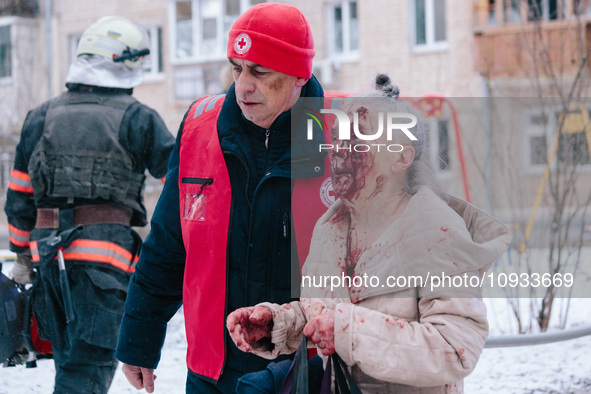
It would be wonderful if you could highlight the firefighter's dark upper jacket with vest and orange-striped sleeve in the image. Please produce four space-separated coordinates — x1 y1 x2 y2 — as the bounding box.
4 85 174 253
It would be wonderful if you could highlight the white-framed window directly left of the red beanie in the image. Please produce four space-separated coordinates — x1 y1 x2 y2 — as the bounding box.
172 0 264 61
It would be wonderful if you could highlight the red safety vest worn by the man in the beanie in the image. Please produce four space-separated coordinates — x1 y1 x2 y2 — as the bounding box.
179 95 334 380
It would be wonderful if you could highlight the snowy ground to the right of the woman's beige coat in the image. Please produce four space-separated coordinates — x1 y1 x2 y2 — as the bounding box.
464 298 591 394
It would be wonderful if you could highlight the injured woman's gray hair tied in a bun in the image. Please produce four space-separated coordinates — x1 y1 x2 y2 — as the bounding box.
357 74 449 201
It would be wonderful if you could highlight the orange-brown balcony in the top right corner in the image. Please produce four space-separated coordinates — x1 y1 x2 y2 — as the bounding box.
473 0 591 78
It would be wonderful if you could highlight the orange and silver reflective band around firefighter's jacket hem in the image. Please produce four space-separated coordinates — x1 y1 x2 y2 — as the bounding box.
30 239 138 273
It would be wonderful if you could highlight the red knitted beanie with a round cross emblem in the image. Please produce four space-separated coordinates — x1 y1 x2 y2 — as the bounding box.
228 3 315 78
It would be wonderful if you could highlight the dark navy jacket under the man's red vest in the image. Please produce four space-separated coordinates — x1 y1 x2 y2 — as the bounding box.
116 78 324 392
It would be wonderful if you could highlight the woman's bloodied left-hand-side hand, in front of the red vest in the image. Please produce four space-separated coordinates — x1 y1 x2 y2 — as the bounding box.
226 306 273 352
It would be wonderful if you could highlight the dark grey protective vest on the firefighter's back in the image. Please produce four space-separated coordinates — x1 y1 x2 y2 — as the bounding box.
29 91 146 219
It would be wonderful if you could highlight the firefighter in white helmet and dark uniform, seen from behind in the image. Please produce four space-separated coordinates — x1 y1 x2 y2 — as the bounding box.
5 16 174 393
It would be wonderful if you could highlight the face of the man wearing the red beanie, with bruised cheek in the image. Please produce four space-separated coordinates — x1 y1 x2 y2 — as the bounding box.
230 58 308 129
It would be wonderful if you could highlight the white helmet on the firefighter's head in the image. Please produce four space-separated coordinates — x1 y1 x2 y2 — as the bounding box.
76 16 148 68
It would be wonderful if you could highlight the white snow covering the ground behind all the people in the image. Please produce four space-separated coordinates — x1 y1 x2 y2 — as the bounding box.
0 262 591 394
